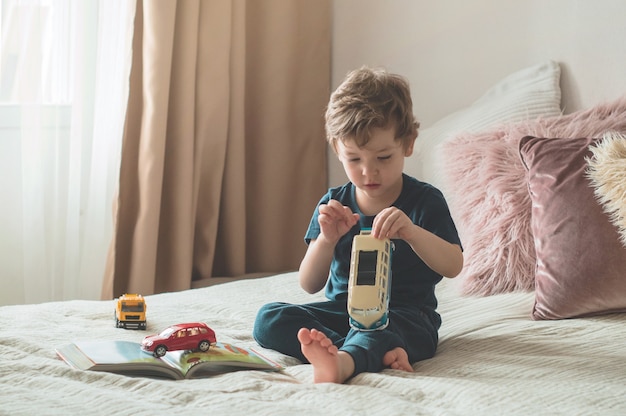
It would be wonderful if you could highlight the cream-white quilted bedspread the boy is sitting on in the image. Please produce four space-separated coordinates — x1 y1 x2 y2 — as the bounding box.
0 273 626 416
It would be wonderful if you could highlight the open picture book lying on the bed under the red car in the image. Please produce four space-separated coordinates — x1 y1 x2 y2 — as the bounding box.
56 341 282 380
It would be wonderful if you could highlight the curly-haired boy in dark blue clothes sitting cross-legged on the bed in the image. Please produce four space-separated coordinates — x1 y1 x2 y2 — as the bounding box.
254 67 463 383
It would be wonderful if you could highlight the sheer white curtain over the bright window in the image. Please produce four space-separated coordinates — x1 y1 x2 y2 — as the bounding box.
0 0 135 305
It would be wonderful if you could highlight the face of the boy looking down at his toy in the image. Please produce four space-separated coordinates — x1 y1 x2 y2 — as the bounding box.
337 128 414 211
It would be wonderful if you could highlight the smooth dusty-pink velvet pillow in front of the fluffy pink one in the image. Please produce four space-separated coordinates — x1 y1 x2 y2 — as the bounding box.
520 136 626 320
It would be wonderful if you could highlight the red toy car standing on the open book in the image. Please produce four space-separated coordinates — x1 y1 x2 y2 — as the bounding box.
141 322 216 357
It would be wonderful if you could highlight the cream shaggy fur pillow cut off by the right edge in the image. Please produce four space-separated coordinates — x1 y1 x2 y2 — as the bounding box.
587 132 626 247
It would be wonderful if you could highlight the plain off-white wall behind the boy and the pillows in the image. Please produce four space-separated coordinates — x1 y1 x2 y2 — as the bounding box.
329 0 626 186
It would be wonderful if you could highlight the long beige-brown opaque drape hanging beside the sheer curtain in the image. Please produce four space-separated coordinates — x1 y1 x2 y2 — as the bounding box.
102 0 330 299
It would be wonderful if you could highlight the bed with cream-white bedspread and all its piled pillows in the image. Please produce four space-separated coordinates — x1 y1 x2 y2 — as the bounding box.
0 61 626 415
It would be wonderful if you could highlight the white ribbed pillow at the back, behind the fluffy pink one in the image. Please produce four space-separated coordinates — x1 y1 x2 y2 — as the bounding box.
405 61 561 194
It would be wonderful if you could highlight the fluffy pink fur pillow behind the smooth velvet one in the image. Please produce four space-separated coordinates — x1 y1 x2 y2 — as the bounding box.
441 96 626 296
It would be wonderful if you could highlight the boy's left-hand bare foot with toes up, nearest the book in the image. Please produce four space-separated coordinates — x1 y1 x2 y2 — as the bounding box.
298 328 354 383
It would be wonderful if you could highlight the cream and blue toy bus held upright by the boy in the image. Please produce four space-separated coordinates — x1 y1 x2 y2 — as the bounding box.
348 229 393 331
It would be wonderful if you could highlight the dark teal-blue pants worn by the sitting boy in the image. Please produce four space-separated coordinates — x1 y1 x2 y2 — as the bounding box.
253 300 438 376
